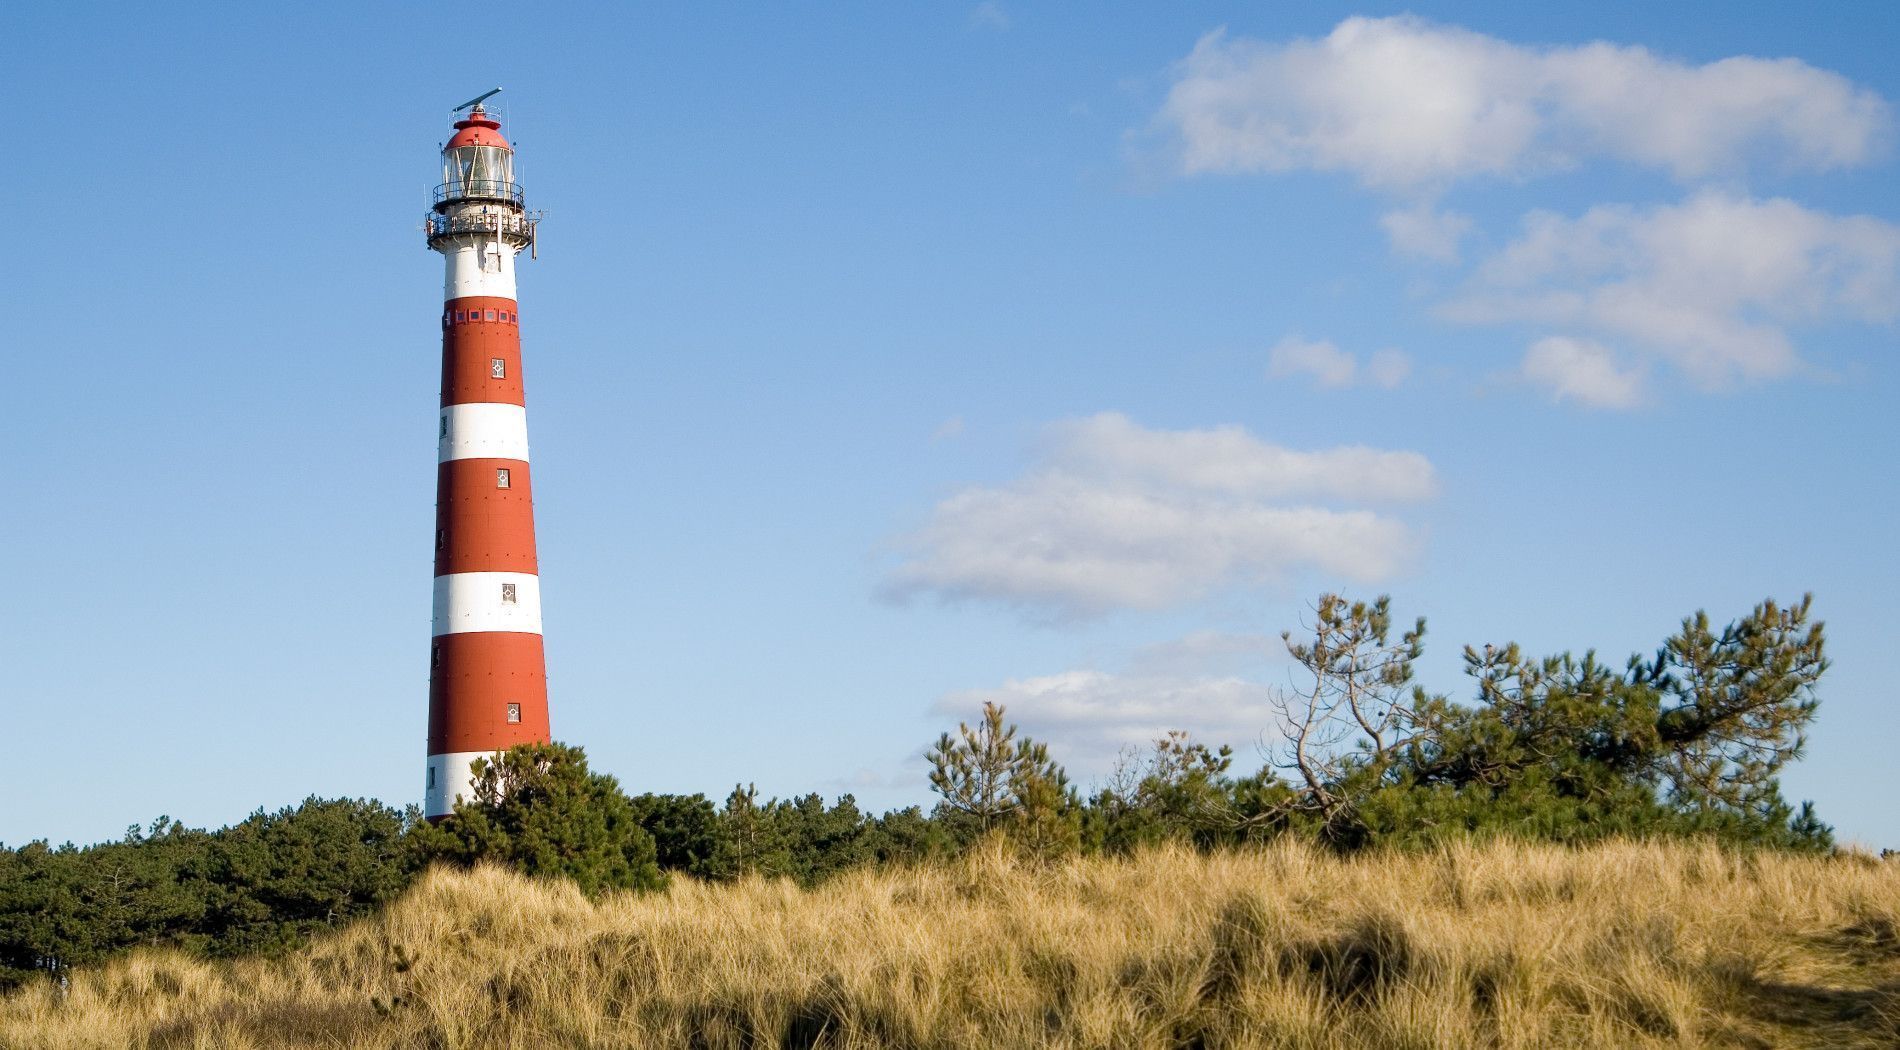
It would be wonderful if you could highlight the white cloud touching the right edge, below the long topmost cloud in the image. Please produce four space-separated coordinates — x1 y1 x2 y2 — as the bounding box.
1440 192 1900 387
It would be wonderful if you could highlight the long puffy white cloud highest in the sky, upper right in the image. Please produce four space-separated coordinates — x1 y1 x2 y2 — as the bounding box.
1157 17 1892 188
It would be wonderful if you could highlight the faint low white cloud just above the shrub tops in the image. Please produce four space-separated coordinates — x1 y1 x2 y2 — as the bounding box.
933 670 1273 782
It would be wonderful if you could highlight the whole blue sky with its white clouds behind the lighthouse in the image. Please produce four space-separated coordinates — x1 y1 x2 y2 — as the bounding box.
0 2 1900 845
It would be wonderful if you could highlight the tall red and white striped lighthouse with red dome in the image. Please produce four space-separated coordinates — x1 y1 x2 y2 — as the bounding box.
424 87 549 818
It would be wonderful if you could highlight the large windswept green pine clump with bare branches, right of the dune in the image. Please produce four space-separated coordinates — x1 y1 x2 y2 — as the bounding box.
1246 594 1832 849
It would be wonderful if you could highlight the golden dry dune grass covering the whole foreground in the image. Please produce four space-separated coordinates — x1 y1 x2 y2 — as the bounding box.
0 843 1900 1048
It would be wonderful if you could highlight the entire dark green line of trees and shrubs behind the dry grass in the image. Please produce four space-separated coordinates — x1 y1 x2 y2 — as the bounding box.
0 594 1834 989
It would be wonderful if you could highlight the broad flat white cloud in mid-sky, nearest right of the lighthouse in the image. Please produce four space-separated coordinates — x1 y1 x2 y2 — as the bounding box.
884 412 1436 619
